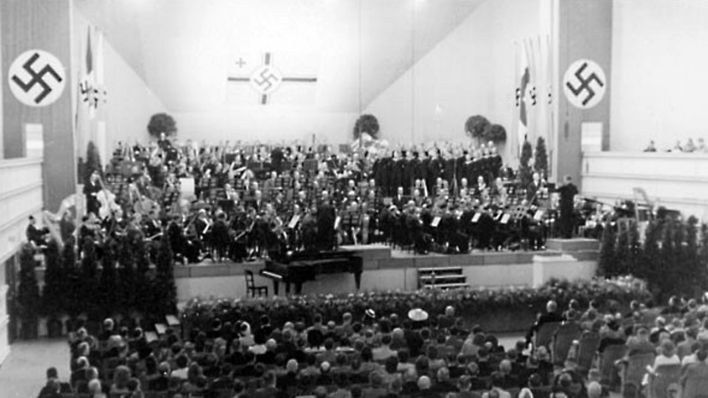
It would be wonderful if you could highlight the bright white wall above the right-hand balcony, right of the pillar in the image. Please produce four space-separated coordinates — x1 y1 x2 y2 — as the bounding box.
610 0 708 151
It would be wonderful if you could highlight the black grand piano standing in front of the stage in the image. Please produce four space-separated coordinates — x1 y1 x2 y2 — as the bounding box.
260 249 363 294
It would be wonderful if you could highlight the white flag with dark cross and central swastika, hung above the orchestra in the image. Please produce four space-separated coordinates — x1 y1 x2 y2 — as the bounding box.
225 51 319 106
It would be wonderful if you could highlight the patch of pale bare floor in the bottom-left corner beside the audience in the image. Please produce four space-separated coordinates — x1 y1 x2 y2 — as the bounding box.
0 338 69 398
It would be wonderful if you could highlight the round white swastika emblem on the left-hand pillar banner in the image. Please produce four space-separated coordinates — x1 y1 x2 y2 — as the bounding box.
7 49 66 107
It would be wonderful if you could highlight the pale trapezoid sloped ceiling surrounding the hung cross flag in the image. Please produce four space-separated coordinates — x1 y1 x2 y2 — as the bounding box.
75 0 485 112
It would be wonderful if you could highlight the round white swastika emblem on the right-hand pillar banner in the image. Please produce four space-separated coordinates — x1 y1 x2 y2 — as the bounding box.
563 59 607 109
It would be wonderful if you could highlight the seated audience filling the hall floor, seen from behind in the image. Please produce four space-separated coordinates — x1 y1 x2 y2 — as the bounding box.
39 288 708 398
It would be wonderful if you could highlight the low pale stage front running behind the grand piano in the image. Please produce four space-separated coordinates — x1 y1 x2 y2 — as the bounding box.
175 239 599 302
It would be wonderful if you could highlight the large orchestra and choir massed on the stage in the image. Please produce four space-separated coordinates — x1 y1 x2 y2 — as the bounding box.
62 140 588 263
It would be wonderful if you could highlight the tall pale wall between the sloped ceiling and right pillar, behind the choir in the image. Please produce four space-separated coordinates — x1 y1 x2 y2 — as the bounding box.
366 0 548 161
